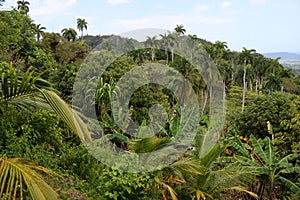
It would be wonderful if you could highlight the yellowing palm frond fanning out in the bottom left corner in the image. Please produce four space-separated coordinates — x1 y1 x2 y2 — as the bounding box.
0 158 59 200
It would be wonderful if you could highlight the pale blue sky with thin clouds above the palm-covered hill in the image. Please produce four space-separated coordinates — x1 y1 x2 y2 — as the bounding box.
0 0 300 53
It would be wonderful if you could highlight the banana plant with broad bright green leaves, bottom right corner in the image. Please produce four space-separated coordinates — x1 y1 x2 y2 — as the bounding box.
230 135 300 199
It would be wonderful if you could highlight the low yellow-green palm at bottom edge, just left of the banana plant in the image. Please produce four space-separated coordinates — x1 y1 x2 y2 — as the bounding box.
184 140 257 200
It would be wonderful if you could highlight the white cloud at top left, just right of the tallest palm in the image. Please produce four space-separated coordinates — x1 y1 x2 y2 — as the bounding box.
29 0 77 16
